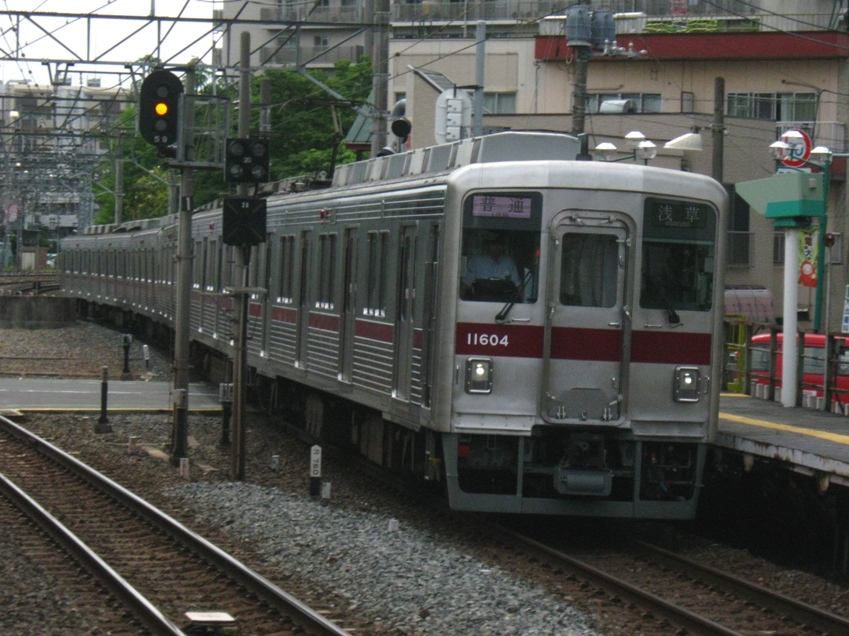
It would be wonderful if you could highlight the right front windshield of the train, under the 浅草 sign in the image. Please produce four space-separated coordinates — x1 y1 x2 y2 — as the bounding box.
640 199 716 311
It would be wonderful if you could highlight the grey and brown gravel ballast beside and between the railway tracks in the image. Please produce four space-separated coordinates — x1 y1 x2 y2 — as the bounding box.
6 323 847 636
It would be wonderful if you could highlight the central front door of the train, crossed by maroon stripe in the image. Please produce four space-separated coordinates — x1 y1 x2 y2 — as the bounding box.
542 212 630 422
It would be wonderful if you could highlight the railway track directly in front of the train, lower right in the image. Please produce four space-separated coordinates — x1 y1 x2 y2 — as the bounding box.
497 527 849 636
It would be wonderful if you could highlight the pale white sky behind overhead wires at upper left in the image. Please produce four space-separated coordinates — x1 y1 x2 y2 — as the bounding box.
0 0 222 88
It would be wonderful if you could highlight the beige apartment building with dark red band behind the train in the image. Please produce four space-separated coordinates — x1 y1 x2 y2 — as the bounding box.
215 0 849 329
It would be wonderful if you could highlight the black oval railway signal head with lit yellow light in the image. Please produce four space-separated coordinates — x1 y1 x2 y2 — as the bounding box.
139 70 183 154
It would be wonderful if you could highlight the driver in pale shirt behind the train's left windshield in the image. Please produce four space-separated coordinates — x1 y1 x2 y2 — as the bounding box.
460 231 522 301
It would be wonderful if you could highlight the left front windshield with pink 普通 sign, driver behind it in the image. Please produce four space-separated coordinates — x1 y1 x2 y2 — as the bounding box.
460 192 542 303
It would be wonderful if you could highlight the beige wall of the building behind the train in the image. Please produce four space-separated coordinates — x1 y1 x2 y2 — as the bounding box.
390 35 849 331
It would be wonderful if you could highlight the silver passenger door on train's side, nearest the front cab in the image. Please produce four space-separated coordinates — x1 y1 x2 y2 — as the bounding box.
392 225 416 400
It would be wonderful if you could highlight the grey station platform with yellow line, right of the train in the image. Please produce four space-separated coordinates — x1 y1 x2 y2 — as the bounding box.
714 393 849 492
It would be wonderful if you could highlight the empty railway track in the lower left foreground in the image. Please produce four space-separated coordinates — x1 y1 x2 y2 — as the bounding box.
0 418 348 636
